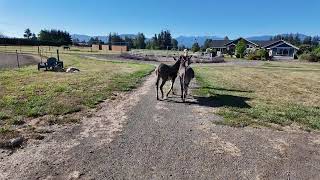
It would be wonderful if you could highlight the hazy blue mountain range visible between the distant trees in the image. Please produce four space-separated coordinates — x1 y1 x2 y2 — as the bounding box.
71 34 307 47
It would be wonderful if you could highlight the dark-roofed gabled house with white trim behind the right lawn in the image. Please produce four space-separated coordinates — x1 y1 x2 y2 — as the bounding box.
212 37 299 59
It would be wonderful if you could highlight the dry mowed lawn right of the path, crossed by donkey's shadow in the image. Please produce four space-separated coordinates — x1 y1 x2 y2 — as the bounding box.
195 62 320 130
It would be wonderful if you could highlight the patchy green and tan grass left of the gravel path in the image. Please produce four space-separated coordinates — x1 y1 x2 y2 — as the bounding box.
0 55 154 127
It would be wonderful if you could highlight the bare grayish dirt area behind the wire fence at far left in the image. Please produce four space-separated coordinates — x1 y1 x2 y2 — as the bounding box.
0 53 40 69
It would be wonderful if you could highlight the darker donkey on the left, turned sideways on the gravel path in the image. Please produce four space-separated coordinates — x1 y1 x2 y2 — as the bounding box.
155 56 182 100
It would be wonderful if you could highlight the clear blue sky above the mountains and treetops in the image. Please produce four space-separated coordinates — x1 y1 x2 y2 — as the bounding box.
0 0 320 38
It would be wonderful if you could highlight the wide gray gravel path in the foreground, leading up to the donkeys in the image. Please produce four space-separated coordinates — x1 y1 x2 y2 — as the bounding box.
0 67 320 179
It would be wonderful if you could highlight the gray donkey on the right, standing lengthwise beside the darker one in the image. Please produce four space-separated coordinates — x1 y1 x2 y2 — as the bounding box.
179 56 194 102
